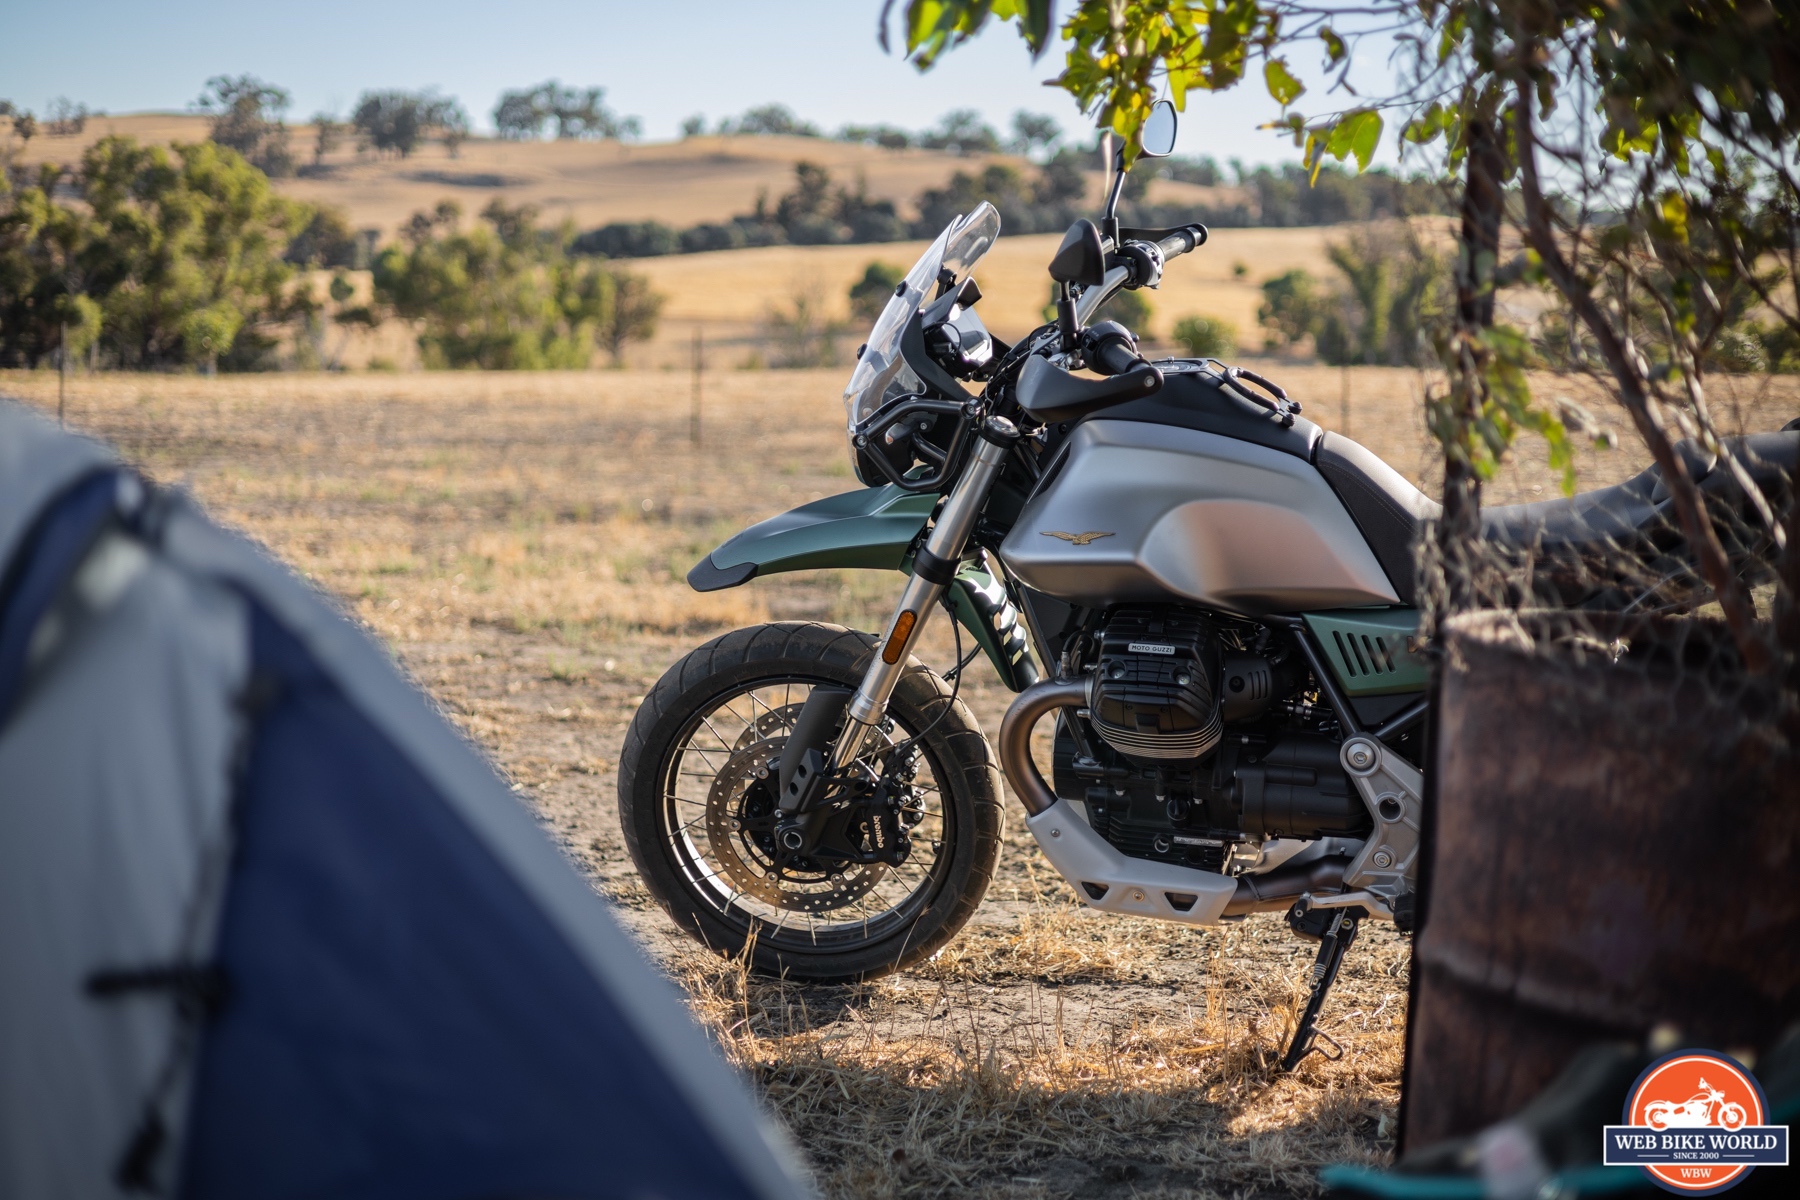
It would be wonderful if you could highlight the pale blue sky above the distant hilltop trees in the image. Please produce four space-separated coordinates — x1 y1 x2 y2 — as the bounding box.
0 0 1404 162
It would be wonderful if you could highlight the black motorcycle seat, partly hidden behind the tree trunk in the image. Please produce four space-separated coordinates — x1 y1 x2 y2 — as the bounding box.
1314 430 1800 604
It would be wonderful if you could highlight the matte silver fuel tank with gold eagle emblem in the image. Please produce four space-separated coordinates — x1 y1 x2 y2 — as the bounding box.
1001 419 1399 615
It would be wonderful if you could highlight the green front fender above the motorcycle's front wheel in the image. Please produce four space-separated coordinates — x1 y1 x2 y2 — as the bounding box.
688 484 1039 691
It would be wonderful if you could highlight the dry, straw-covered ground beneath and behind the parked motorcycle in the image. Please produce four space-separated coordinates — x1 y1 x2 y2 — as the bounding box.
0 363 1800 1196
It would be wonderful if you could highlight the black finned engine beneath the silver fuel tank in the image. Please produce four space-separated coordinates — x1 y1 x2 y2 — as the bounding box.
1055 606 1370 871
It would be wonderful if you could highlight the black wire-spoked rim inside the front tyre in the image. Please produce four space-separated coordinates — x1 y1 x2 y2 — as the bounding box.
659 675 956 954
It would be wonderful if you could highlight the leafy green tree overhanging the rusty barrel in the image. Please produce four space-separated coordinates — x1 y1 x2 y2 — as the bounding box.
882 0 1800 683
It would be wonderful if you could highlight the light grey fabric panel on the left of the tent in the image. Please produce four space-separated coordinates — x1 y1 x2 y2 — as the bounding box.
0 467 247 1196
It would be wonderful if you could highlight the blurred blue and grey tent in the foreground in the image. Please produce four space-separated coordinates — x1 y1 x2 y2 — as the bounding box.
0 401 805 1200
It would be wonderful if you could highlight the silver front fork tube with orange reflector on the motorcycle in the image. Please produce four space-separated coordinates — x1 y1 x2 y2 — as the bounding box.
832 417 1019 768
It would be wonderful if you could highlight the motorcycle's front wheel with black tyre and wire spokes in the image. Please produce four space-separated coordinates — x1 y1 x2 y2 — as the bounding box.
619 622 1001 982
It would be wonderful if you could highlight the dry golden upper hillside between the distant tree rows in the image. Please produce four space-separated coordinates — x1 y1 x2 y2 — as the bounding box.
3 113 1208 236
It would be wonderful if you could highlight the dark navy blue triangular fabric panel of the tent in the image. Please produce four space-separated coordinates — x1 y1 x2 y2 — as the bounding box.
184 612 781 1200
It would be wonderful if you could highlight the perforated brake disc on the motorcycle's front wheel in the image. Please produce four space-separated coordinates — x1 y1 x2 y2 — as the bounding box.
706 737 887 912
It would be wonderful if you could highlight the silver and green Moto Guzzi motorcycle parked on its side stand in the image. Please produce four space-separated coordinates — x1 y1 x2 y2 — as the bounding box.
619 103 1800 1065
